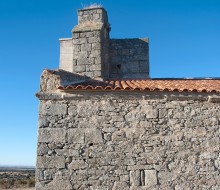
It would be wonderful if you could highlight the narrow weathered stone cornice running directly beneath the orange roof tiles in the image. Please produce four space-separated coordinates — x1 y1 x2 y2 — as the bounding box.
35 90 220 103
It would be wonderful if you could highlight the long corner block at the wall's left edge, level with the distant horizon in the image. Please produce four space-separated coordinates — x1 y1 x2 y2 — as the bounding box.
37 156 65 169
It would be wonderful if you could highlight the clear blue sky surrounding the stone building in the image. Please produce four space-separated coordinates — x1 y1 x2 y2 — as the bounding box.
0 0 220 166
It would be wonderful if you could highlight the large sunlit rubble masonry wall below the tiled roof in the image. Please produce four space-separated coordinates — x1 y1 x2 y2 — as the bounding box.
36 92 220 190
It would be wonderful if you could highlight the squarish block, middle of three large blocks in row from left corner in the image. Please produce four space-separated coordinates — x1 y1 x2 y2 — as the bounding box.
67 128 85 144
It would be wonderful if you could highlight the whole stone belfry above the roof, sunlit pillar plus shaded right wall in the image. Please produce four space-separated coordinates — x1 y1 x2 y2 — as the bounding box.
60 7 149 80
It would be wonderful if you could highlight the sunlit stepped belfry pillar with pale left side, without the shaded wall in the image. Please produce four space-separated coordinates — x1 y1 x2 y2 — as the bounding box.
60 7 110 79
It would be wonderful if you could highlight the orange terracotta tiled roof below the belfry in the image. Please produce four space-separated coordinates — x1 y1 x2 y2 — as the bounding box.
58 79 220 93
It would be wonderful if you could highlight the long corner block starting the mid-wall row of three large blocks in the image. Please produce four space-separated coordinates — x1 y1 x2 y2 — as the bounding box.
38 128 66 143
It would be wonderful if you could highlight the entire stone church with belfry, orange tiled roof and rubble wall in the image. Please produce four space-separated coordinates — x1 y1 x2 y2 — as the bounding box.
36 7 220 190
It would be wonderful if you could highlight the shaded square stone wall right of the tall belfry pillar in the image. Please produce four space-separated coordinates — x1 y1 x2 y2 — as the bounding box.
110 38 149 78
